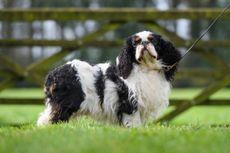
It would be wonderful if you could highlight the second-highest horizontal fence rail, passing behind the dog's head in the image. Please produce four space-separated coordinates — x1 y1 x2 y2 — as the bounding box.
0 39 230 48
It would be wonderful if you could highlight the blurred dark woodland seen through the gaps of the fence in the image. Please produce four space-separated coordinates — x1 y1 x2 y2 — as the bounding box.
0 0 230 87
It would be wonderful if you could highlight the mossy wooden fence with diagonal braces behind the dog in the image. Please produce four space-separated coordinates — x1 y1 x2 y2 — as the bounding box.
0 8 230 121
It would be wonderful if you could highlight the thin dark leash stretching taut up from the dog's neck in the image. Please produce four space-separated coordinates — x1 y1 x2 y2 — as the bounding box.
163 3 230 71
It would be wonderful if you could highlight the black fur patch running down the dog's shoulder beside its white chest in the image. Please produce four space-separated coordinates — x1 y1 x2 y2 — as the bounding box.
106 66 137 123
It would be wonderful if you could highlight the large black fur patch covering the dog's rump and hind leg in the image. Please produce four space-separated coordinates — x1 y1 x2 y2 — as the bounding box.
45 64 85 123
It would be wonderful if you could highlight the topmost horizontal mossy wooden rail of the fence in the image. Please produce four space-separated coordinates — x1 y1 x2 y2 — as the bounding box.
0 8 230 22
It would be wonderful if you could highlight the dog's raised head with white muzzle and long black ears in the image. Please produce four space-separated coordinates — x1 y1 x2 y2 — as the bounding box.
116 31 181 80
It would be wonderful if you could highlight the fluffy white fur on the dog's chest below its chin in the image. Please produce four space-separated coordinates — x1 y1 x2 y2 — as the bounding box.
126 65 170 123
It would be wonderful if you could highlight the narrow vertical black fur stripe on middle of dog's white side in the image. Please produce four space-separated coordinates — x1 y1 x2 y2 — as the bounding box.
94 69 105 110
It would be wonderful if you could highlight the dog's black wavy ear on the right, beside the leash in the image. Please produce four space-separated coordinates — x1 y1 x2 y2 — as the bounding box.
156 36 181 81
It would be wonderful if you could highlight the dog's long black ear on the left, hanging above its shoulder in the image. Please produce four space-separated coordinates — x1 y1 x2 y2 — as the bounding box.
117 37 135 79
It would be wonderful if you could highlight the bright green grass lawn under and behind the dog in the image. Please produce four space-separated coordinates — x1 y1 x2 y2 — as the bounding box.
0 89 230 153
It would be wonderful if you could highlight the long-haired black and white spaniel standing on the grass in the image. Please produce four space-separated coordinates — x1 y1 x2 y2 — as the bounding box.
37 31 181 127
